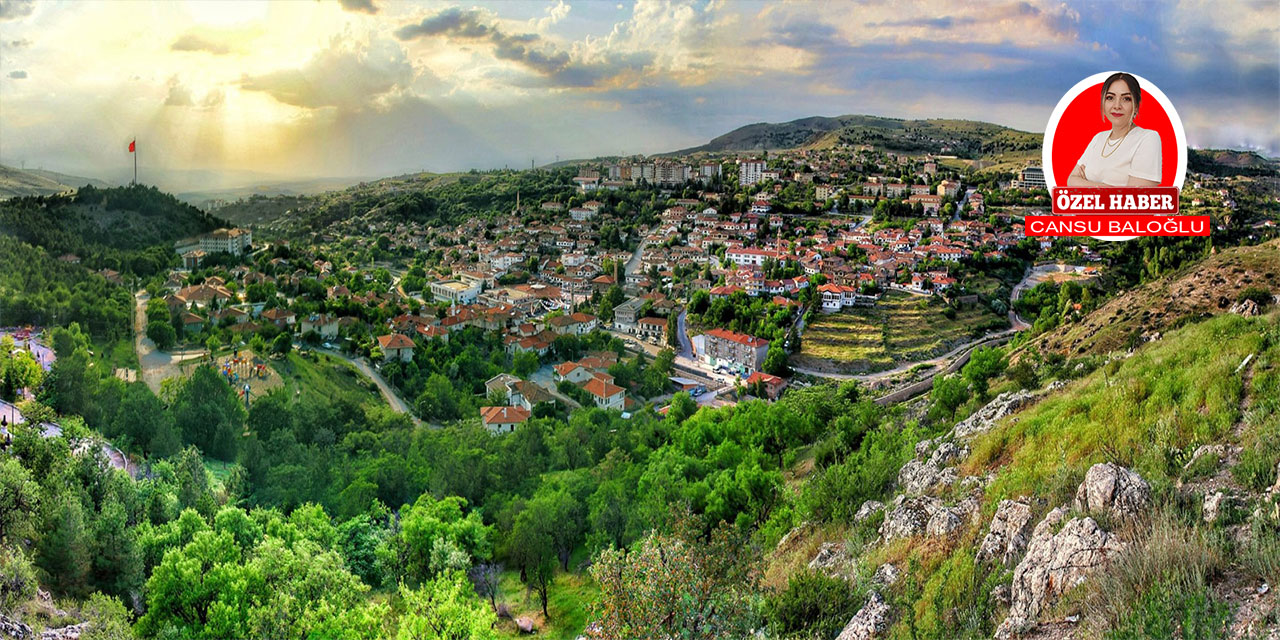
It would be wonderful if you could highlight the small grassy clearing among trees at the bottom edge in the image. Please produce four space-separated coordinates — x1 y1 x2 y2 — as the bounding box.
497 565 600 640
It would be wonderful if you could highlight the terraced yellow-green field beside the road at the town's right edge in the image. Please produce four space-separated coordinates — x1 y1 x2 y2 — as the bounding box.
792 292 1002 371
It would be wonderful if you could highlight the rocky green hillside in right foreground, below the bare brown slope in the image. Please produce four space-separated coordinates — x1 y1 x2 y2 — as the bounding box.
765 306 1280 639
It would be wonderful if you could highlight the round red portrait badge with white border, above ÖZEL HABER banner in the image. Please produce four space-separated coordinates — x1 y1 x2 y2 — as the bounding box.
1042 72 1187 189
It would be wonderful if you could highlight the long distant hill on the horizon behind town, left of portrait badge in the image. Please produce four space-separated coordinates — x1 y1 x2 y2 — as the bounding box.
668 115 1042 159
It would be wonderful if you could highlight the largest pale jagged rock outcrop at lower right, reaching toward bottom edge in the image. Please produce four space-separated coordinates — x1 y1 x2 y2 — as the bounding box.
996 507 1124 639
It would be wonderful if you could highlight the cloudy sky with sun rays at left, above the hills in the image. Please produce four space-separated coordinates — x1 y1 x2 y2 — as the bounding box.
0 0 1280 188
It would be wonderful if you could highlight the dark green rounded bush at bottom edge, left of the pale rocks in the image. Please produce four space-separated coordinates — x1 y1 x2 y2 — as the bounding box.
764 570 865 640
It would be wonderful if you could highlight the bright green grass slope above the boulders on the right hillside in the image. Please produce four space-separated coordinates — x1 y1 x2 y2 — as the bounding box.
964 315 1264 504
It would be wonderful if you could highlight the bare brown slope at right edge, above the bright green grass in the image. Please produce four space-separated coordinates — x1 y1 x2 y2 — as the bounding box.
1032 239 1280 356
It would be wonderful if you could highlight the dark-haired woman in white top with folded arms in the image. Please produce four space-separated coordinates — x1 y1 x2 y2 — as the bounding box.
1066 73 1161 187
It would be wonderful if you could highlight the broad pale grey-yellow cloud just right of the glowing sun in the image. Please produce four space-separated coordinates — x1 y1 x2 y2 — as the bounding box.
239 36 415 110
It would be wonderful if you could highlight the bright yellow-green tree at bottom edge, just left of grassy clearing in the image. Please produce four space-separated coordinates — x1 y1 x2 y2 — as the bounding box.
396 571 498 640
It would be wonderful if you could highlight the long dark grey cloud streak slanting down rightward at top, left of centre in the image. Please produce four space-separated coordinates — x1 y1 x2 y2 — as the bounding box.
396 5 652 87
